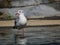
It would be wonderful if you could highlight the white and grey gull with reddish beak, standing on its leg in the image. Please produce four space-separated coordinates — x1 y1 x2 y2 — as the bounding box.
15 10 27 37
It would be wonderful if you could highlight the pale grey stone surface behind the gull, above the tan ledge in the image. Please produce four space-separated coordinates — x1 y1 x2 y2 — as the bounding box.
0 0 60 16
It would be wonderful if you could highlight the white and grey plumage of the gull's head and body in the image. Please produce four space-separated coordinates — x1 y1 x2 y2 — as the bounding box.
16 10 27 26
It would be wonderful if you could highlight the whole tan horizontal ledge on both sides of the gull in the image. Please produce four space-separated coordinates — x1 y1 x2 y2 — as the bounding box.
0 20 60 28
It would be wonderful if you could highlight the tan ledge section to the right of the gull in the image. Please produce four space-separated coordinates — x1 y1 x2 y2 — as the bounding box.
27 20 60 26
